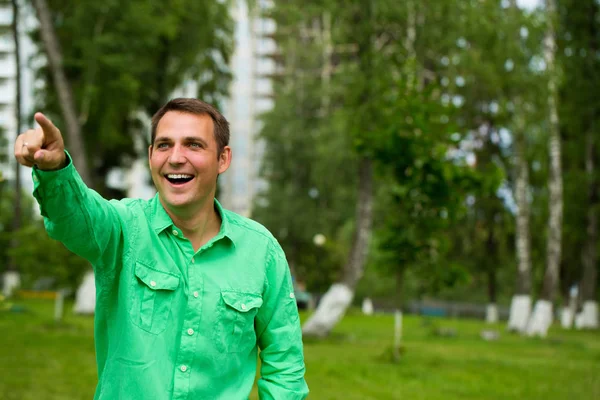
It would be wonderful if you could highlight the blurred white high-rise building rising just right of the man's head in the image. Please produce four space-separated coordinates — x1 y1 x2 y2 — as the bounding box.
219 0 276 216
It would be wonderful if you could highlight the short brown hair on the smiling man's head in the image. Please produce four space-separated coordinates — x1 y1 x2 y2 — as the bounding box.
150 98 229 157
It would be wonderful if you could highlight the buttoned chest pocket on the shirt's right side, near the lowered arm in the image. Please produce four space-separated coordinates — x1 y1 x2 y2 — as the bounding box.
215 290 263 353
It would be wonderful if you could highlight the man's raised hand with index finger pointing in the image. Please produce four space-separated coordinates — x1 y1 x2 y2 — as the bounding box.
15 113 67 171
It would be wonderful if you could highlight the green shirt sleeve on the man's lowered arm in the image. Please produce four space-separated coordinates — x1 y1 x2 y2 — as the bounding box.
256 244 308 400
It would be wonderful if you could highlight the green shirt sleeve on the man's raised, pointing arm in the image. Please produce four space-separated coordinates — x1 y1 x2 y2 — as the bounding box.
32 152 122 283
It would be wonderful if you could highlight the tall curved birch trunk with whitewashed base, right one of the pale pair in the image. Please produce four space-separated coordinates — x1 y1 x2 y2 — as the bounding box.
527 0 563 337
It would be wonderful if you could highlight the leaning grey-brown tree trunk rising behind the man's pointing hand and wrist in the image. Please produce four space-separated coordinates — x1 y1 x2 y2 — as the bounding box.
33 0 92 186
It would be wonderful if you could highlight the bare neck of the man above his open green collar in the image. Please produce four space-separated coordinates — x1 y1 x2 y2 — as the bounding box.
161 197 221 251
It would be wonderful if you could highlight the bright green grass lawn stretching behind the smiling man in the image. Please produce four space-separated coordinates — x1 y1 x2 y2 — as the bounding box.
0 301 600 400
